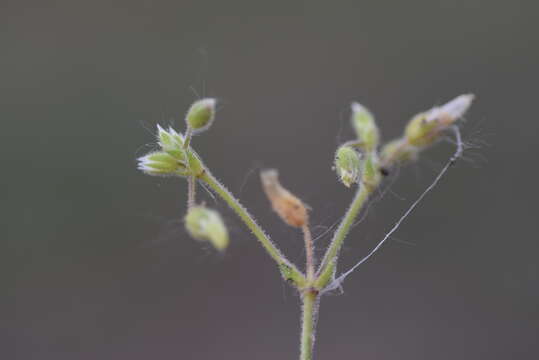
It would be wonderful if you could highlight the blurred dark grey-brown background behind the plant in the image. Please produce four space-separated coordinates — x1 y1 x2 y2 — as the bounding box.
4 0 539 360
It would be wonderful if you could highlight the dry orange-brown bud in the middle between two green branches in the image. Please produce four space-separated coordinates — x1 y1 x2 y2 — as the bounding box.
260 169 309 227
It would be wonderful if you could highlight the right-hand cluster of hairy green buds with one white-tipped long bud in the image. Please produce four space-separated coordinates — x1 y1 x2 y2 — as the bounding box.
334 94 474 187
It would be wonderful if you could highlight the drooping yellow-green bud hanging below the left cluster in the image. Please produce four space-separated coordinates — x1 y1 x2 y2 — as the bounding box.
185 206 229 251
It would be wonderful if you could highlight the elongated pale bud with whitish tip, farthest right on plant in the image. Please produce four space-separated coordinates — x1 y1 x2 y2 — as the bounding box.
405 94 474 147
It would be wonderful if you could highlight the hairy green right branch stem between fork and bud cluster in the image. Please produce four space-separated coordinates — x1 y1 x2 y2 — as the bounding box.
315 184 377 289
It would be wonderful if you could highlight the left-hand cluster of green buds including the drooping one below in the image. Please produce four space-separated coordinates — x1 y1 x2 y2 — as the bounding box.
137 98 229 251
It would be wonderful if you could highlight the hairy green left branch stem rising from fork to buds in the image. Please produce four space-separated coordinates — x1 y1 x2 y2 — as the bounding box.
200 169 305 286
